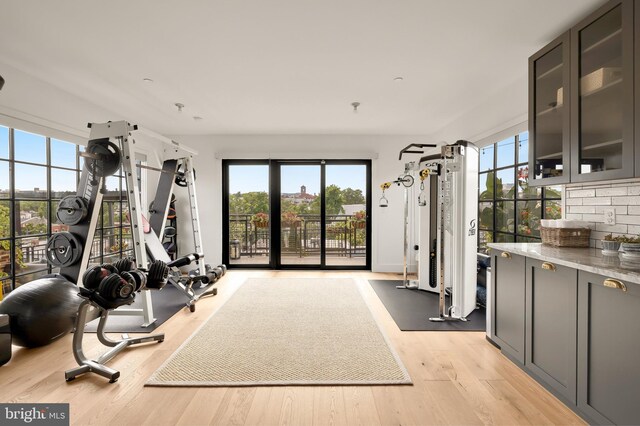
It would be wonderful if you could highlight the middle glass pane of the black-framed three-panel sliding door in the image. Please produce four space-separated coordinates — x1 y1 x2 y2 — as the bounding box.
280 164 322 266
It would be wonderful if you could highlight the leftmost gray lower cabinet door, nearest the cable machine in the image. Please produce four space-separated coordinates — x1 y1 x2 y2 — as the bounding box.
491 250 525 364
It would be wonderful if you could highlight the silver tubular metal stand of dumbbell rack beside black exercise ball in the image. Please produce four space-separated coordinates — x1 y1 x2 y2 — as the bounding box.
64 289 164 383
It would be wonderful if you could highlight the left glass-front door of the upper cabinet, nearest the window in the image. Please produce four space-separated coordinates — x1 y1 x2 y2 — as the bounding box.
529 31 571 185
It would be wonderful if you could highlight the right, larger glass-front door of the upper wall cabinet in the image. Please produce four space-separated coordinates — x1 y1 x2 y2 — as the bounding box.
571 0 634 182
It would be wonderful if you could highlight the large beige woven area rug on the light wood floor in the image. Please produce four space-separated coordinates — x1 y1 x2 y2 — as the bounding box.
146 278 411 386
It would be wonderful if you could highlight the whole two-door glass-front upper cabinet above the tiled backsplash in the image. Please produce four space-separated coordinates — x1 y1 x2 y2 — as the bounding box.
529 0 640 186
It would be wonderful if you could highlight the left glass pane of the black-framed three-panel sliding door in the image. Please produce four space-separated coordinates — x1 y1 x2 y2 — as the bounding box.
228 164 271 265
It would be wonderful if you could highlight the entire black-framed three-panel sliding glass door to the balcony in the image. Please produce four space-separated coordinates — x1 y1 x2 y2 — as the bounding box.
223 160 371 269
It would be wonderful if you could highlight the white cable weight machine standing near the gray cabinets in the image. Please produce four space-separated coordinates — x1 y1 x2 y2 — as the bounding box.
378 141 478 321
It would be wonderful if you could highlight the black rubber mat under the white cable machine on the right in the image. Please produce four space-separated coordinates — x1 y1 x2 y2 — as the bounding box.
369 280 486 331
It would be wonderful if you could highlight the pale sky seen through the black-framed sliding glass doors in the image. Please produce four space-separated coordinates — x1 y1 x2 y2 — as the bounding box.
229 164 367 194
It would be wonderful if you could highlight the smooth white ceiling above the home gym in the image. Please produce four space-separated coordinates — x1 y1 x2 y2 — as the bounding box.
0 0 603 135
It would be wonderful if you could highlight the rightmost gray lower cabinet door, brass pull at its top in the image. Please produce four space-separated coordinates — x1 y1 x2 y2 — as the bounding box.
578 271 640 425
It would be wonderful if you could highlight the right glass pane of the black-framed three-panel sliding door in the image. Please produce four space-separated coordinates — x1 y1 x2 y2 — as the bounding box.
324 164 369 266
